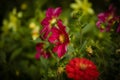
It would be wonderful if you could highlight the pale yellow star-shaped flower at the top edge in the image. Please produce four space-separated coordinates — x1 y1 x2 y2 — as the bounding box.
70 0 94 14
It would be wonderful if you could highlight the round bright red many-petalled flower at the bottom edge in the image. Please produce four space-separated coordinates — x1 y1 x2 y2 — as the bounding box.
66 58 99 80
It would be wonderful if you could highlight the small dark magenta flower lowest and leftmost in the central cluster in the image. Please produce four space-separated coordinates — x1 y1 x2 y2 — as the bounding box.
35 43 50 59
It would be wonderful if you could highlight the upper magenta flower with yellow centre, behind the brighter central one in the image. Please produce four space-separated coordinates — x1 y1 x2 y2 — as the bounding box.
40 7 62 39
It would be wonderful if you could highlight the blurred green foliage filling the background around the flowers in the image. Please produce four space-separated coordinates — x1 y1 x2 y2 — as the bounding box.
0 0 120 80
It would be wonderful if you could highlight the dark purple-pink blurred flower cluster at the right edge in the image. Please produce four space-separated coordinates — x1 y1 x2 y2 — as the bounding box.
96 5 120 32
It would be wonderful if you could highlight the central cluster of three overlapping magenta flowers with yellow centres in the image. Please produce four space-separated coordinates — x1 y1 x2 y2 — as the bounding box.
36 7 69 59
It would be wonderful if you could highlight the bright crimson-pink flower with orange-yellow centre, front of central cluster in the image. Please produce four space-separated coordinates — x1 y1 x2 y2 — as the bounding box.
48 20 69 58
